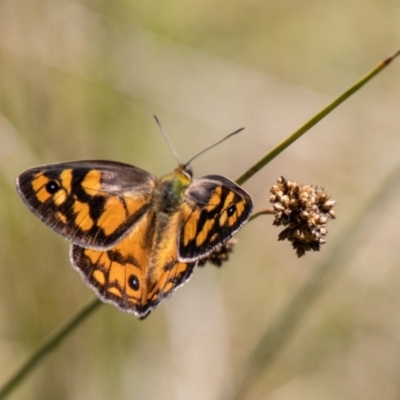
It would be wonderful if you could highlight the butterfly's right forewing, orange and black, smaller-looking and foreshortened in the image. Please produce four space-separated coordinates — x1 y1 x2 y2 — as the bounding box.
178 175 253 262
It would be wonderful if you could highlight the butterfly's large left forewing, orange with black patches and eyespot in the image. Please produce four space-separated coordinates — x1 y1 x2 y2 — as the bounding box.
17 161 157 248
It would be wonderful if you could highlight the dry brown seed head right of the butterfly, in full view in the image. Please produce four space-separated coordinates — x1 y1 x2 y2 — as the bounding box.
269 176 336 257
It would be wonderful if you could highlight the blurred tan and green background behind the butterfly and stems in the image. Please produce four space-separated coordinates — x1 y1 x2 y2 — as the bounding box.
0 0 400 400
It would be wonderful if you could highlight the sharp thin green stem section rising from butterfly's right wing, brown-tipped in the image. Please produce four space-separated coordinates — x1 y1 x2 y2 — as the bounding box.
236 50 400 185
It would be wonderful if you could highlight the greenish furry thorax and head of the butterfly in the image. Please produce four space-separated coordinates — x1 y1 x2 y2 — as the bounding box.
154 165 192 214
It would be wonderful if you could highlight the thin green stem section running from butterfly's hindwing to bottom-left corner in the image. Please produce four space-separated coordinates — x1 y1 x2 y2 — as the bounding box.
0 298 103 399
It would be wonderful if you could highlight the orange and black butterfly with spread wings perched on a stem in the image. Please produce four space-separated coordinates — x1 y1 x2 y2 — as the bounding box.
17 147 253 319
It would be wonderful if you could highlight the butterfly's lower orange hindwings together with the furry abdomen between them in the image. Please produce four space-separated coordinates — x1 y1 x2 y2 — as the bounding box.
71 211 195 318
